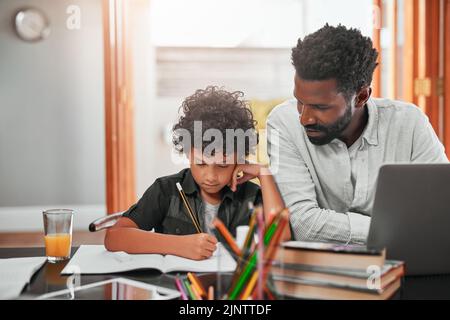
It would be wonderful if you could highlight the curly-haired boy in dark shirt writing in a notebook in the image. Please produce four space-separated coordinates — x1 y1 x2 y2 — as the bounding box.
105 87 290 260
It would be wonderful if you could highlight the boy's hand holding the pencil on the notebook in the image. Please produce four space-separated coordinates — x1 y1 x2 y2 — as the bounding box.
180 233 217 260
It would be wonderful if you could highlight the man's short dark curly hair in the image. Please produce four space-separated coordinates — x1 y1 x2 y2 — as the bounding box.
292 24 378 96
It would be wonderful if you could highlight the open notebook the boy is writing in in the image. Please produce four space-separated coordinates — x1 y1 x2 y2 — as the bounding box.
61 244 236 274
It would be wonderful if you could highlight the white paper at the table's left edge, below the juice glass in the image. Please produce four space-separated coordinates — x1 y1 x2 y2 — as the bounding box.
0 257 47 300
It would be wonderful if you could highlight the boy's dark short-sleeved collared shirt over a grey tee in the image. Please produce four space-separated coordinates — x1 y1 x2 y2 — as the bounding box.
123 169 262 235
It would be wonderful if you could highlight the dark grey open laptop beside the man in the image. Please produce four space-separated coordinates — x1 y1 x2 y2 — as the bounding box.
367 164 450 275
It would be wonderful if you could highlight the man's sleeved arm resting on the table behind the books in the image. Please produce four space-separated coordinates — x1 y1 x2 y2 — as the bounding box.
267 111 370 244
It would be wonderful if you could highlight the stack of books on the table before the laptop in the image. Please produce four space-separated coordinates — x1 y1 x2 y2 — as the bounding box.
271 241 405 300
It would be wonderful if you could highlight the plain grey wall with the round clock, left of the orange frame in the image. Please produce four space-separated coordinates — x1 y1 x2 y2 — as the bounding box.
0 0 105 231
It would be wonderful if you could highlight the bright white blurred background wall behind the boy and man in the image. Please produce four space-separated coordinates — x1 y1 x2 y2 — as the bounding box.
133 0 372 197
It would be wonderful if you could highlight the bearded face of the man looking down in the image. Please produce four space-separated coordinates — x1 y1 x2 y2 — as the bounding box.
294 75 354 145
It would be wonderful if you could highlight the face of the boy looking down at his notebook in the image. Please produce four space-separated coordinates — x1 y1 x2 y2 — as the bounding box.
189 148 236 194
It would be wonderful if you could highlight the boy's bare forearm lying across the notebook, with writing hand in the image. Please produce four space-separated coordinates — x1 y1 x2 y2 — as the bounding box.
105 218 217 260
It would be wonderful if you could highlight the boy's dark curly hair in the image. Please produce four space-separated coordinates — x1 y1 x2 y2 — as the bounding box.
172 86 258 156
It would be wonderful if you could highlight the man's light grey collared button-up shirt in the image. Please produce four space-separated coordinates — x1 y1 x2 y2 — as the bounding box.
267 99 448 244
